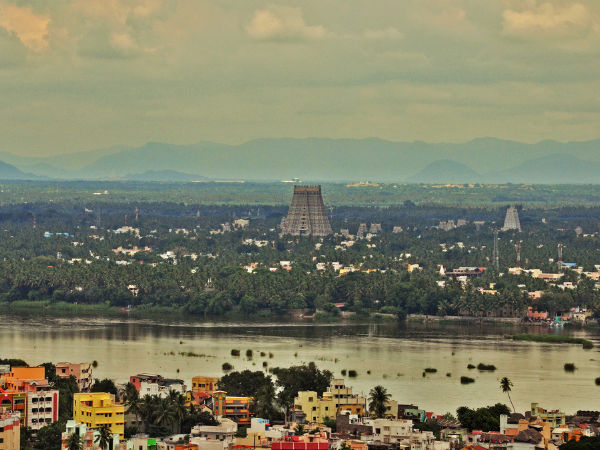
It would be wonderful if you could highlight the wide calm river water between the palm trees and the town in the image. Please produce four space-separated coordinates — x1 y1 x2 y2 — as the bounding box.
0 316 600 413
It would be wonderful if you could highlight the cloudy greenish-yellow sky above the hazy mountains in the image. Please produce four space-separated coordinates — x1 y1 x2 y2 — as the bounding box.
0 0 600 156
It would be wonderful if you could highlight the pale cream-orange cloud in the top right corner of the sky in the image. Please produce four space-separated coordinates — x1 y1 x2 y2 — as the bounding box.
502 2 593 37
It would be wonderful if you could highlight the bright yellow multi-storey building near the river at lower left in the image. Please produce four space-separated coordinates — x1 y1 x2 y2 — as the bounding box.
73 392 125 439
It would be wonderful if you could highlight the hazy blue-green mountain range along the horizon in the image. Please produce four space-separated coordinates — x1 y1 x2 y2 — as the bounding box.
0 138 600 184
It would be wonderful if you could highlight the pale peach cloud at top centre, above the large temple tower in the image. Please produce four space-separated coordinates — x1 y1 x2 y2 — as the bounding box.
246 7 327 41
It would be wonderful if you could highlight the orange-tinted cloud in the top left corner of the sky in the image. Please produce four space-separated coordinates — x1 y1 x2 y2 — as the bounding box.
0 2 50 52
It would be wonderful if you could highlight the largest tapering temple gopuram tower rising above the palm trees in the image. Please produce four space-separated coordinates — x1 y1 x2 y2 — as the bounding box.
281 186 333 236
